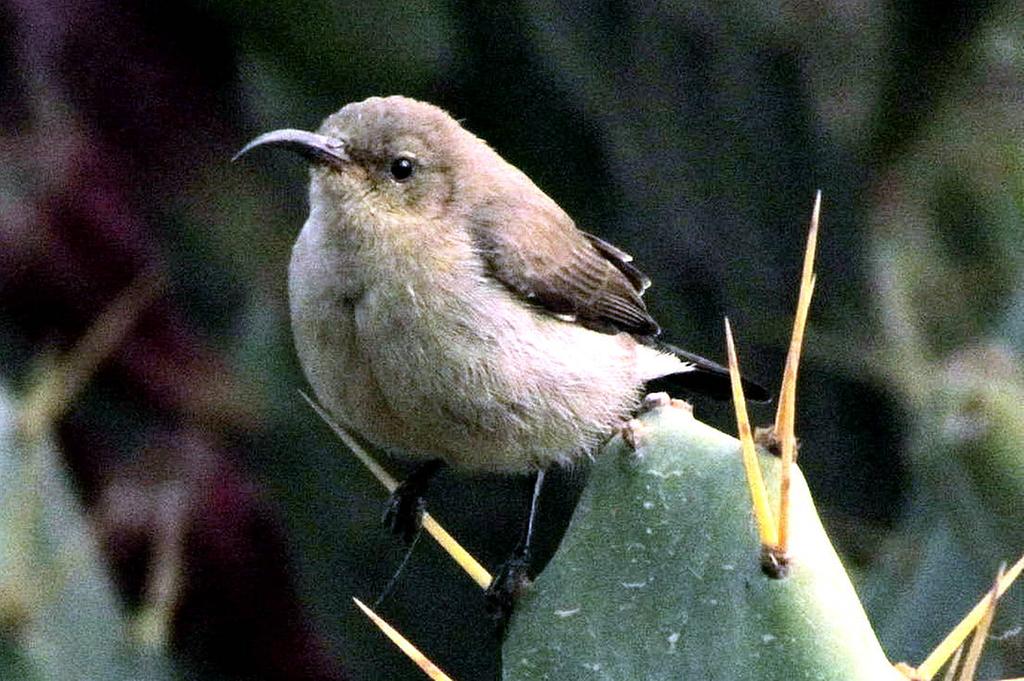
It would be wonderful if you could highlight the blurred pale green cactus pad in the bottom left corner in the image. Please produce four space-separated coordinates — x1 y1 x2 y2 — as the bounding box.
0 382 172 681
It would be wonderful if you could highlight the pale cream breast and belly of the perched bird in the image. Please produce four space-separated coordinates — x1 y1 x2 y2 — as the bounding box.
290 214 648 472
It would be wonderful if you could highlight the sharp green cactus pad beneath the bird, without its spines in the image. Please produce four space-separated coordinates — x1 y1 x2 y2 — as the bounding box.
503 408 903 681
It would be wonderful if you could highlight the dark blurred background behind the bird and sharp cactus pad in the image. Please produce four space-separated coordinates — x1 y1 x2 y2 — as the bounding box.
0 0 1024 680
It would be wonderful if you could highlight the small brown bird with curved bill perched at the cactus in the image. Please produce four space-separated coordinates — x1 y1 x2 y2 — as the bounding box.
236 96 767 606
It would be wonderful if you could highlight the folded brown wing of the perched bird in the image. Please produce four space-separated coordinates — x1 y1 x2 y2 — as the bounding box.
470 195 659 336
